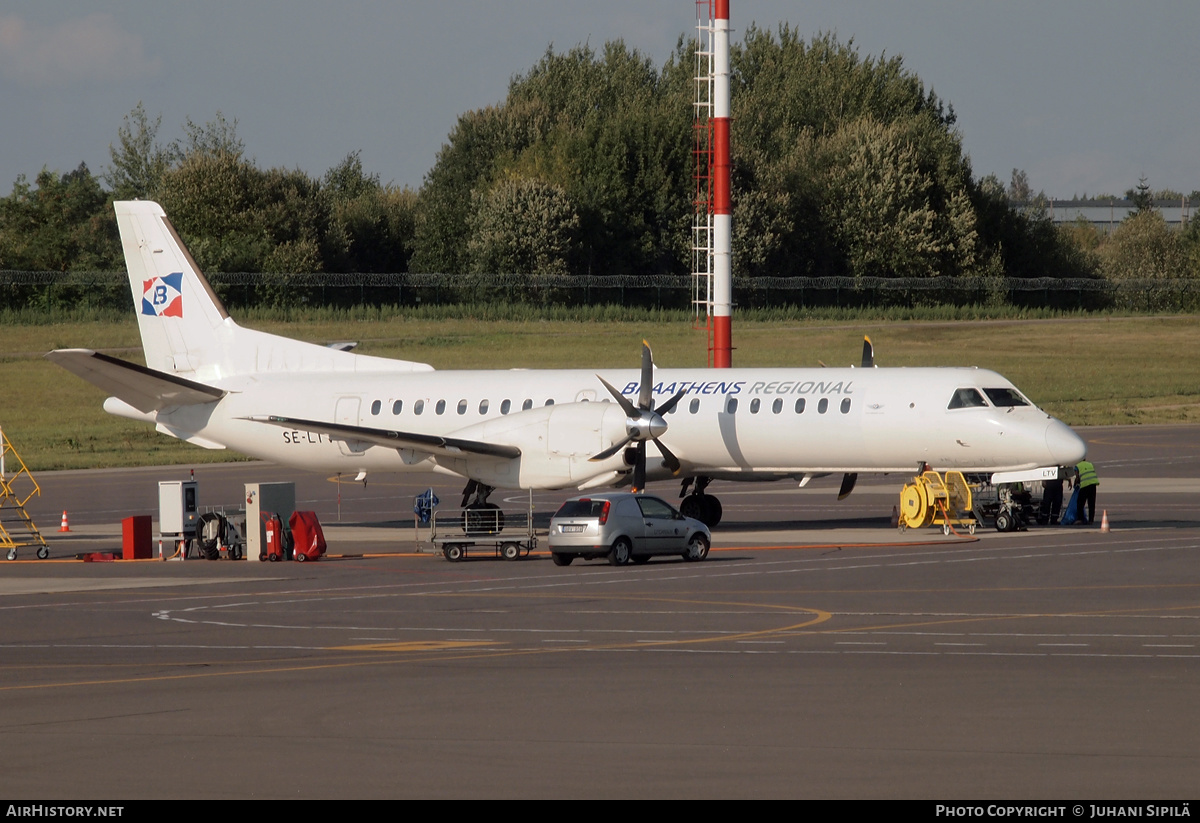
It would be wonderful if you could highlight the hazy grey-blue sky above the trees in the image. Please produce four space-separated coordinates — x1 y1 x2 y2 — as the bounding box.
0 0 1200 198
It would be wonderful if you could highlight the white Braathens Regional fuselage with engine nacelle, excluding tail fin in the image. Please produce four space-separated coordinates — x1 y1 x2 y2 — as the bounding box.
142 368 1086 488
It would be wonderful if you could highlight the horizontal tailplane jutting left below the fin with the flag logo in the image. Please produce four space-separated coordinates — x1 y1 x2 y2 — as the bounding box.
46 349 228 414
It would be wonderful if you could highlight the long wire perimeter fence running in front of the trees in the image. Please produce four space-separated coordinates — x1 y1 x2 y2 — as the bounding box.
0 271 1200 312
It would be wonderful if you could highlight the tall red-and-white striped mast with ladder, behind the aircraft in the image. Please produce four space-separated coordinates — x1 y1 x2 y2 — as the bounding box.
692 0 733 368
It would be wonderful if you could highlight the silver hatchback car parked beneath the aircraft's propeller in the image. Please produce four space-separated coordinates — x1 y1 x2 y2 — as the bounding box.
550 492 713 566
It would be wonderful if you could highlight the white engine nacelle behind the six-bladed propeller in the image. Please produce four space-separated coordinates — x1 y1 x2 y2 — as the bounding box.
437 402 629 488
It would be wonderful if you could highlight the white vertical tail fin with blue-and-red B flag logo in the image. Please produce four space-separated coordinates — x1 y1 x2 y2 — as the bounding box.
113 200 432 382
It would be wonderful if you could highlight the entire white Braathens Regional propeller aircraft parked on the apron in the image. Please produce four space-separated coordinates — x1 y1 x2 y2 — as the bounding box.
46 202 1086 525
